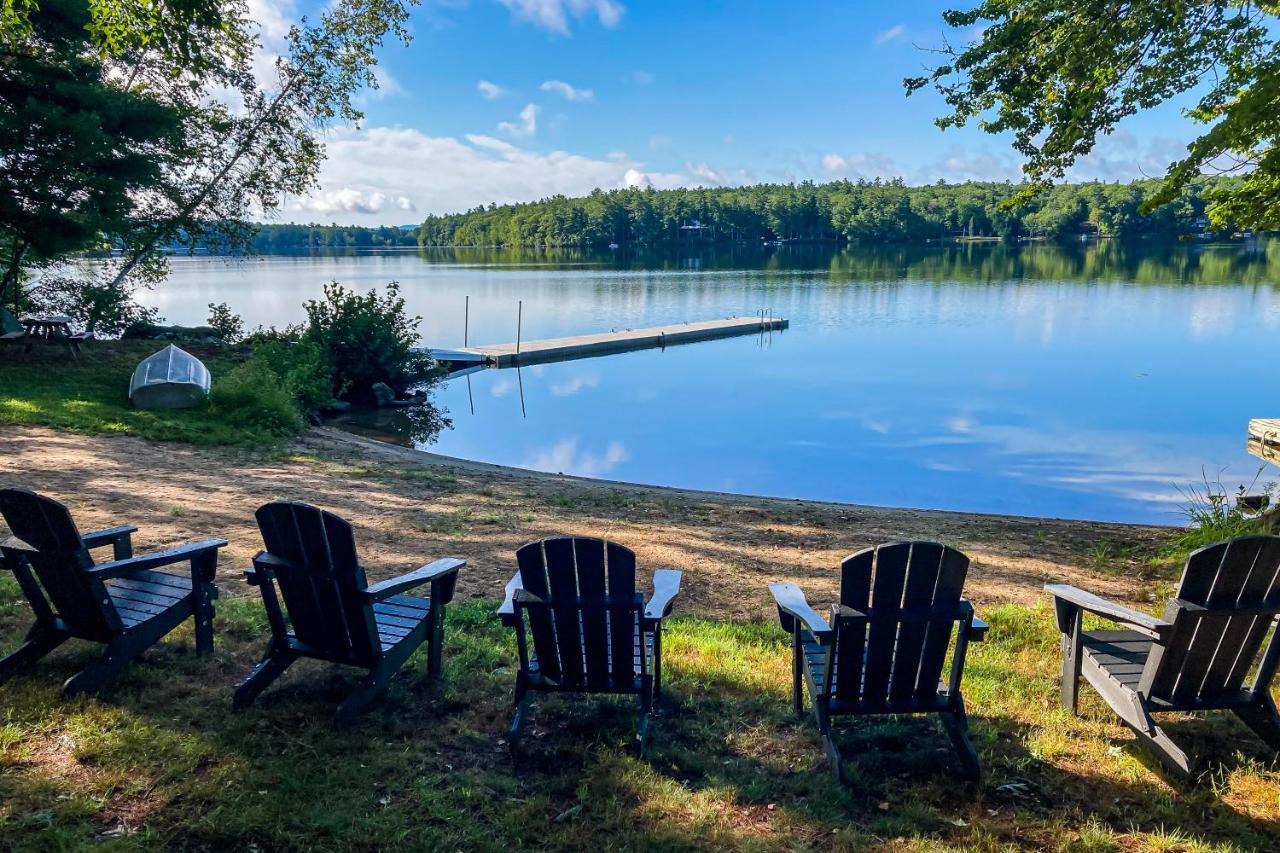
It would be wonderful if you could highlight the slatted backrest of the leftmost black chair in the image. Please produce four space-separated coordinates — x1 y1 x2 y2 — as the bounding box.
0 489 123 640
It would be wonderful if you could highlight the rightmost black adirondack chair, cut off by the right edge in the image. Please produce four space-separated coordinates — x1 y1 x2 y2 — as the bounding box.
1044 535 1280 775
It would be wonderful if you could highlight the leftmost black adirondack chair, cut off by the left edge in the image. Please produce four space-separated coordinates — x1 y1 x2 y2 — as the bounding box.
0 489 227 697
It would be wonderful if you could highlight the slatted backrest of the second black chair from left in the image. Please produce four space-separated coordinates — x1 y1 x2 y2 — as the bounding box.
257 501 381 666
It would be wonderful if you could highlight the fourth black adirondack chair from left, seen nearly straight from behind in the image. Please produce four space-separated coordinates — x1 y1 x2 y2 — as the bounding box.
769 542 987 780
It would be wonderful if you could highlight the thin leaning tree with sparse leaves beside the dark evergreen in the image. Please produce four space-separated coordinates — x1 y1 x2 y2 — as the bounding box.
103 0 417 292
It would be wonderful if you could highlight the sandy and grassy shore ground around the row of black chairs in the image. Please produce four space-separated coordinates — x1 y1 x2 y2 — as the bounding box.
0 427 1280 852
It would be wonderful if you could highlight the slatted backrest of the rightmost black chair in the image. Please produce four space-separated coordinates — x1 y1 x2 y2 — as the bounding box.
1138 535 1280 704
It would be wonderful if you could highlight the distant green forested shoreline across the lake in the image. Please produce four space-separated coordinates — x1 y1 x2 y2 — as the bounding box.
241 178 1259 252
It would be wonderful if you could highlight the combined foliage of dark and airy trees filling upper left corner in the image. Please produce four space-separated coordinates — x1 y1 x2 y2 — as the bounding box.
0 0 417 313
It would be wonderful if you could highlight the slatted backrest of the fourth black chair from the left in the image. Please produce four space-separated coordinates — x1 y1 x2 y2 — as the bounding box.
832 542 969 710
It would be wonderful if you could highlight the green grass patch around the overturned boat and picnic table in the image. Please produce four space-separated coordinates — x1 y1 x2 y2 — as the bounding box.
0 341 262 446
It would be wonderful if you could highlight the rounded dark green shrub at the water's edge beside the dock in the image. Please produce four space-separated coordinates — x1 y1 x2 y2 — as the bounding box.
302 282 438 401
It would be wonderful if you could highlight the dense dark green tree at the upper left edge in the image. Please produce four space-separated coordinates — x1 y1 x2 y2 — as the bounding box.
0 0 183 310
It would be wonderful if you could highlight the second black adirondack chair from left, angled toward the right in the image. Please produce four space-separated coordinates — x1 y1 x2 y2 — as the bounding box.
234 502 466 729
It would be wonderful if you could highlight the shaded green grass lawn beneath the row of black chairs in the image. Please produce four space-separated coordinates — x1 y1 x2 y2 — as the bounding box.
0 575 1280 850
